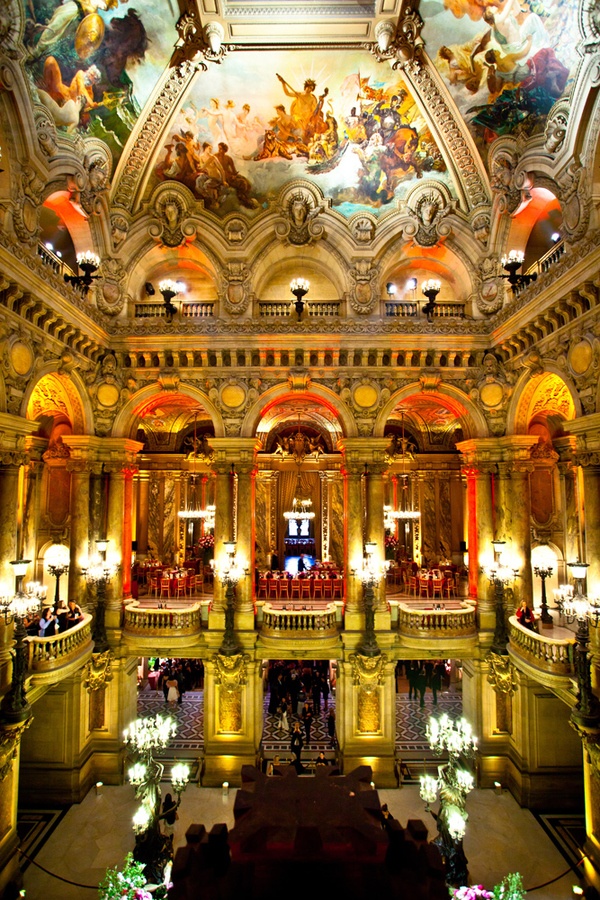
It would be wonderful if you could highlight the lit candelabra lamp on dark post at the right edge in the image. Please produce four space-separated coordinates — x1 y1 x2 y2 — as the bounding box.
555 562 600 728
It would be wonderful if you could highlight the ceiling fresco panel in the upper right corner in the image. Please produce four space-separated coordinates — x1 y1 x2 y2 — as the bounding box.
420 0 579 156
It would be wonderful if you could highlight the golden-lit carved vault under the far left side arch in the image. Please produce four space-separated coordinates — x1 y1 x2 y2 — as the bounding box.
21 363 94 434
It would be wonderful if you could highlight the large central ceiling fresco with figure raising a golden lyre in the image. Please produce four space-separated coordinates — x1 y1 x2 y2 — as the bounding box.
155 50 449 215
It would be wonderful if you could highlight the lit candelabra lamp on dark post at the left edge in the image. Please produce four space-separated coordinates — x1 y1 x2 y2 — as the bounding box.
0 559 45 724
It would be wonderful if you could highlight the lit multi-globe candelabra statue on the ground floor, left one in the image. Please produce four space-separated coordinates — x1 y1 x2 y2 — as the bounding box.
124 714 190 884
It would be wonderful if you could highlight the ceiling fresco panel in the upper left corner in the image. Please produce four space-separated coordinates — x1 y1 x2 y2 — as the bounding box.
24 0 179 161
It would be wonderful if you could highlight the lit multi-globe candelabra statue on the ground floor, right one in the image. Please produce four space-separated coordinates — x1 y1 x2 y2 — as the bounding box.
421 715 477 885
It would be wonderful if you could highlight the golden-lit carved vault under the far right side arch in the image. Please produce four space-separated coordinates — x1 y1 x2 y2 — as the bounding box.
506 360 583 435
